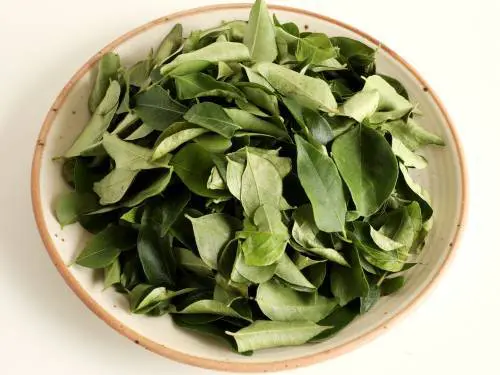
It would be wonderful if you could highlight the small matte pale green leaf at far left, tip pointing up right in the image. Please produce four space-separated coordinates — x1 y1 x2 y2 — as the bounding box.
94 168 139 206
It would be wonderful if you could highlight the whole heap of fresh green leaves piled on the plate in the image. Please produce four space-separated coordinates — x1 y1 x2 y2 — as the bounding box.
55 0 442 353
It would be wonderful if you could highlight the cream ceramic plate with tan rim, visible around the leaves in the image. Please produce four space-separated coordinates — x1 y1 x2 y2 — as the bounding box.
32 4 466 371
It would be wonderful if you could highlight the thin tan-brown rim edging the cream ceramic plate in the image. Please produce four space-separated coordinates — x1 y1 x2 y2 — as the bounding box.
31 3 468 372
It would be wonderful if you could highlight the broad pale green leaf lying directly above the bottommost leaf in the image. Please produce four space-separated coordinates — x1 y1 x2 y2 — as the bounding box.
255 280 337 323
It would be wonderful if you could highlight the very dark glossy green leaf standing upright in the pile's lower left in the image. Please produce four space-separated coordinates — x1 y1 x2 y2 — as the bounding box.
137 225 176 287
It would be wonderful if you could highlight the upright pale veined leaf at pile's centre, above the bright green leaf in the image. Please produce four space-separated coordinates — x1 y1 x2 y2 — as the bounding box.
241 150 283 217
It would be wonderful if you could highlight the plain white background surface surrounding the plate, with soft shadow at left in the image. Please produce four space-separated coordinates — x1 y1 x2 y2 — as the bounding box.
0 0 500 375
